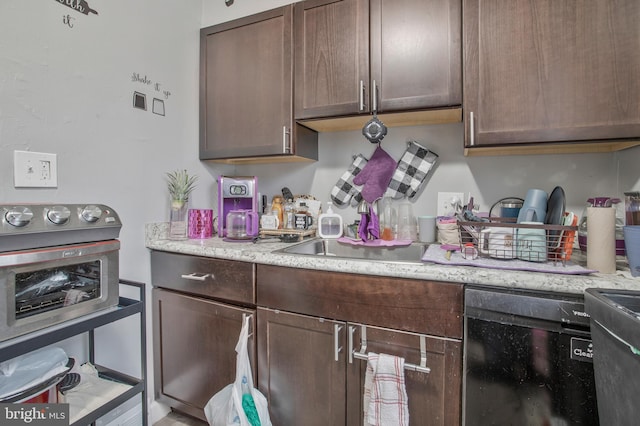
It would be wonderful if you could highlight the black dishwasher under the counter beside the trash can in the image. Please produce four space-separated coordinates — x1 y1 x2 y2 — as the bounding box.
463 287 598 426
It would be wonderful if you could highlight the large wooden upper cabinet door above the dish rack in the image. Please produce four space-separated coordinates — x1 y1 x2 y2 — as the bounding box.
463 0 640 146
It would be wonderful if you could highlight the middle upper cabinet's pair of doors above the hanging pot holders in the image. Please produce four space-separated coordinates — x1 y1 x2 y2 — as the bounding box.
294 0 462 120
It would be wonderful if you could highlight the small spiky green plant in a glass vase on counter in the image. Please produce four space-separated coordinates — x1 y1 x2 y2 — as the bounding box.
167 170 198 240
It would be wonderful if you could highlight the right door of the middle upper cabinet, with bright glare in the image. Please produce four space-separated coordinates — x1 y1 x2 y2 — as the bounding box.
371 0 462 112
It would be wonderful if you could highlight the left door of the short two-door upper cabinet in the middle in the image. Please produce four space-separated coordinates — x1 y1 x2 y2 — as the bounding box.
294 0 369 119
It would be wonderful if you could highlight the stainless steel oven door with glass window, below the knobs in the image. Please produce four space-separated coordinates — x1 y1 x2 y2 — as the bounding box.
0 240 120 341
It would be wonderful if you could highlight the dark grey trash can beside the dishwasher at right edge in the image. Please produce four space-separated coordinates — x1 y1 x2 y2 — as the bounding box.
585 289 640 426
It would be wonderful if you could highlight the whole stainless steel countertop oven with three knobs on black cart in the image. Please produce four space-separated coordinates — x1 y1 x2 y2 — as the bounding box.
0 204 122 341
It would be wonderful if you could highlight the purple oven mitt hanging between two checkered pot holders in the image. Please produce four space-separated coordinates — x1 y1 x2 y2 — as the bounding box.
353 146 397 204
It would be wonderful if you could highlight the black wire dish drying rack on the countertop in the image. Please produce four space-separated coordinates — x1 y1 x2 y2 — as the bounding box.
458 217 578 266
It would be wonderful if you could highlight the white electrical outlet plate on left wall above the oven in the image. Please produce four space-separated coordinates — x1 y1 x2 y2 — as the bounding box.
13 151 58 188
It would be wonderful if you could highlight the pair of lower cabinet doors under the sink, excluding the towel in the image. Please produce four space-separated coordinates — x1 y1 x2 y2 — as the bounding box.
257 308 462 426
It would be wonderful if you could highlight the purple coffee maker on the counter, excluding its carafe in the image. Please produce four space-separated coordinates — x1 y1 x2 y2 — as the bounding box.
218 176 258 237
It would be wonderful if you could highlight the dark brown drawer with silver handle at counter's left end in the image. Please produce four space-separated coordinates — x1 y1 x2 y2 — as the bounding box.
151 251 256 305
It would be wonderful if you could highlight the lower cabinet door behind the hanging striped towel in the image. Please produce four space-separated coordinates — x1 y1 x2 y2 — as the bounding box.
347 323 462 426
